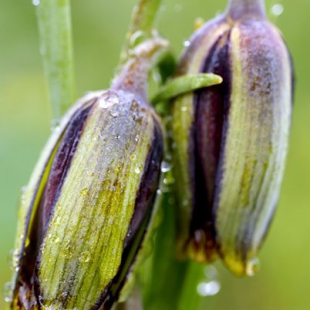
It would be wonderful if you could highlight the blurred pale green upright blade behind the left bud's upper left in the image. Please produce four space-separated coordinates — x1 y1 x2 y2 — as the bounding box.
36 0 74 118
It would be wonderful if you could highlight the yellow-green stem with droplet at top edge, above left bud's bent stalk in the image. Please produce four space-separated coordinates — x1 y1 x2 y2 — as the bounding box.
120 0 161 65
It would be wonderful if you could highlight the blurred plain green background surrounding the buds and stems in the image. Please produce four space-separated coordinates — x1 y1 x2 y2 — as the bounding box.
0 0 310 310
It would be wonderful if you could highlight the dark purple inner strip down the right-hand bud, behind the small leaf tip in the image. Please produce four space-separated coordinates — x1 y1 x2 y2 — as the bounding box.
190 31 231 256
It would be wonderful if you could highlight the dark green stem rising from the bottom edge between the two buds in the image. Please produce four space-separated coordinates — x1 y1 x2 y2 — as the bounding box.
141 193 192 310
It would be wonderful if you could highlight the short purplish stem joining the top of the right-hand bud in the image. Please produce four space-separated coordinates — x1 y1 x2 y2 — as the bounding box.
226 0 266 20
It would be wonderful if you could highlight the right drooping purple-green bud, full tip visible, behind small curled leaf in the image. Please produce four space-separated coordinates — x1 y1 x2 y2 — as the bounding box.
172 0 293 275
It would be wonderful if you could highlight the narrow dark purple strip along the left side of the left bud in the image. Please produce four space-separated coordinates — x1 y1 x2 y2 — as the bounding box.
14 101 91 307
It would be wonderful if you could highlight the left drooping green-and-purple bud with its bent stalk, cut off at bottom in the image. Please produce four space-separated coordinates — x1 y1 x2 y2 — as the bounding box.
11 38 167 309
